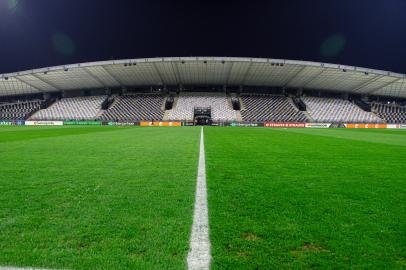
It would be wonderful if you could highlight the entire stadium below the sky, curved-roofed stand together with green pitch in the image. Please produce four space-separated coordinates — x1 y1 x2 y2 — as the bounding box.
0 57 406 270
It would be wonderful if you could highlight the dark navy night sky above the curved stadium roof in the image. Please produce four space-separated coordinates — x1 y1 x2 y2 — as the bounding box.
0 0 406 73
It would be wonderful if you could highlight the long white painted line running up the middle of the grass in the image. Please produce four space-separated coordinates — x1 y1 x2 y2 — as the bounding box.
187 127 211 270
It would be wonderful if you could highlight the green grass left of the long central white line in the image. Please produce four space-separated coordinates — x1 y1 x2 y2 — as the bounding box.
0 127 200 269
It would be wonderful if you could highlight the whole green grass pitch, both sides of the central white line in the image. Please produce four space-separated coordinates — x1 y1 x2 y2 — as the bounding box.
0 126 406 270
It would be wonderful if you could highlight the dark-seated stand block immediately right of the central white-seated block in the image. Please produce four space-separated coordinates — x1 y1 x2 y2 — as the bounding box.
241 94 307 122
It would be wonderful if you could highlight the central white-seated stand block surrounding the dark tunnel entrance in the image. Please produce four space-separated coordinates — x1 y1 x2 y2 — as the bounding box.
168 93 237 121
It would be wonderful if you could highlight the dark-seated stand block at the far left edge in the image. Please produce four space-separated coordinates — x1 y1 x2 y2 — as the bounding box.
0 100 43 120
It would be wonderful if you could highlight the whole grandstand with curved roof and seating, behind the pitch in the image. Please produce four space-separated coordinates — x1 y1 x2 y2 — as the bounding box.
0 57 406 128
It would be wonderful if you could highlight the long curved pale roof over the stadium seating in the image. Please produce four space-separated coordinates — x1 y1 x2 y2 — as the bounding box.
0 57 406 97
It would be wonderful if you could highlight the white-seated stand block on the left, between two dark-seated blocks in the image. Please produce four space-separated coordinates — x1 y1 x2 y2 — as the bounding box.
30 96 107 120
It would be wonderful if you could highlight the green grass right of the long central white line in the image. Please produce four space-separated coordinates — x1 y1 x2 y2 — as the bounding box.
205 128 406 269
